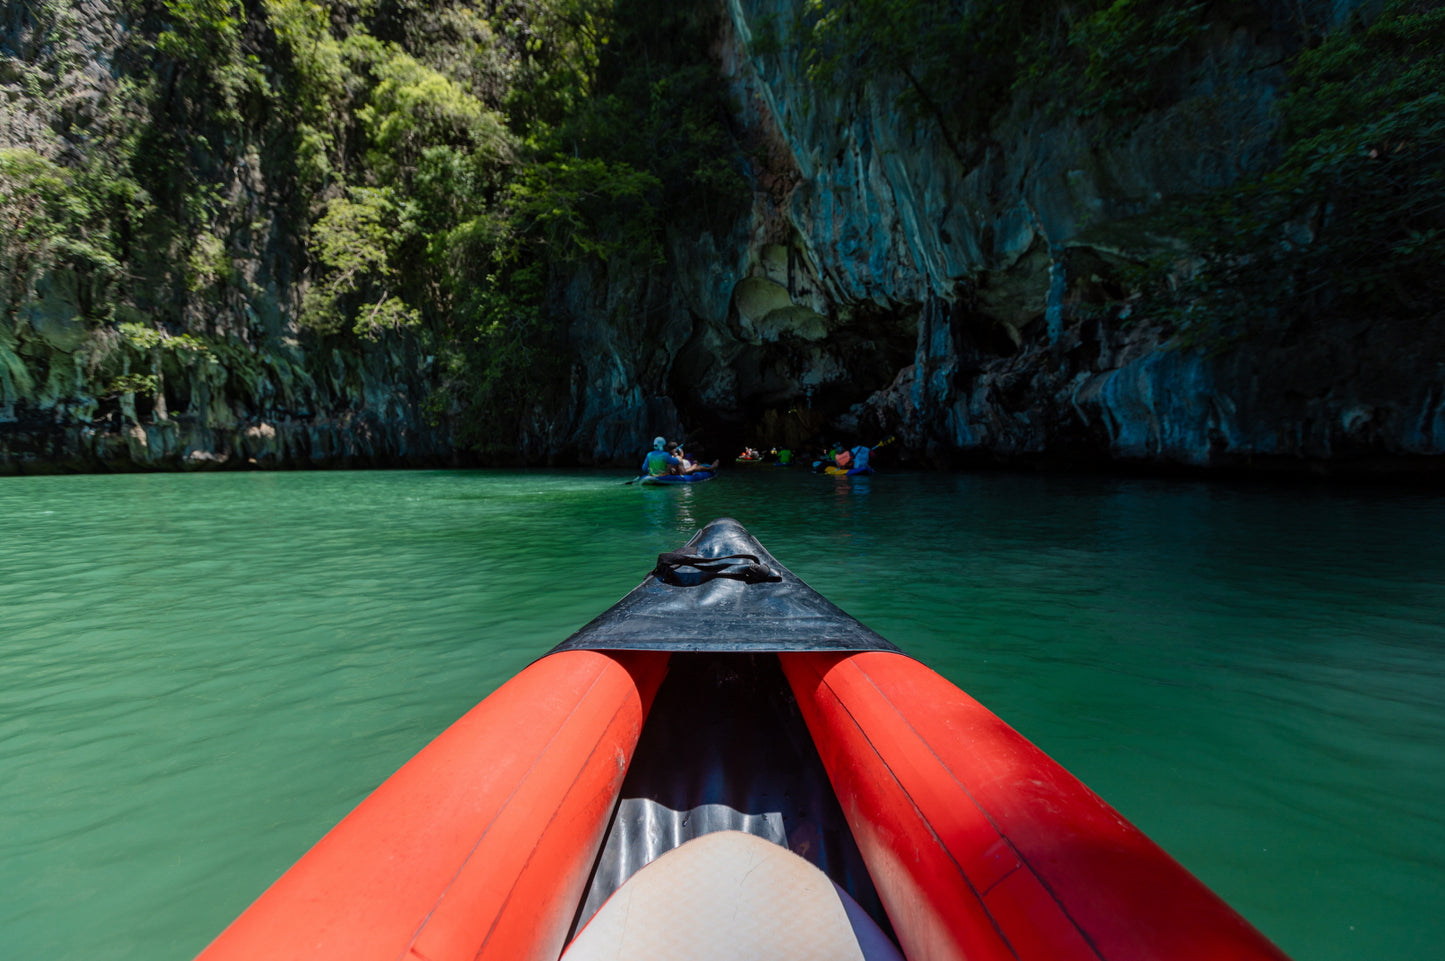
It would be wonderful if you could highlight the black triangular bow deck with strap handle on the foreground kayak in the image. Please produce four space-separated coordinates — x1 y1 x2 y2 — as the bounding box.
549 517 897 653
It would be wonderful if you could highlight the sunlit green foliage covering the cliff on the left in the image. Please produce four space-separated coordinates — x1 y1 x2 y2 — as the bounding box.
0 0 746 449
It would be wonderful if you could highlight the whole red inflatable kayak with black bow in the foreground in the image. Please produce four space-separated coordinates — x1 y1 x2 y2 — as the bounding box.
199 519 1283 961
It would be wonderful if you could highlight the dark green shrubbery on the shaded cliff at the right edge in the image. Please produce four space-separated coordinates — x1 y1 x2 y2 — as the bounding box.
1156 0 1445 345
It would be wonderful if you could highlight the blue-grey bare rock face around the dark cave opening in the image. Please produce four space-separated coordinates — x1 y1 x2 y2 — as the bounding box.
557 0 1445 471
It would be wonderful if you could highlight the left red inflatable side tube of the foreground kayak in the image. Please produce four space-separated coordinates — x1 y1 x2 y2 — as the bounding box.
199 650 668 961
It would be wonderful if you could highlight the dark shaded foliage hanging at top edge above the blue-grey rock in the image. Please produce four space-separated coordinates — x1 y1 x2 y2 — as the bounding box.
786 0 1236 160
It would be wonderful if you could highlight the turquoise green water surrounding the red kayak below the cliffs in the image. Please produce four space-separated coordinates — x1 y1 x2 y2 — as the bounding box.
0 468 1445 961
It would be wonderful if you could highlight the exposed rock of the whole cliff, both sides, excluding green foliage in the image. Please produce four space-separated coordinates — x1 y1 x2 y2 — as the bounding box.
0 0 1445 471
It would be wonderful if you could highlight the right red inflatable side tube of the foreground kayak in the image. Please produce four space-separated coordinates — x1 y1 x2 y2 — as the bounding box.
779 652 1285 961
